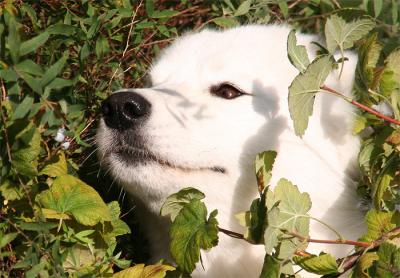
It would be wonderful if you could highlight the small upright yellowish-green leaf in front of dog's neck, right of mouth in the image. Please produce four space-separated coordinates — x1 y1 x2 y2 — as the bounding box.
254 151 277 194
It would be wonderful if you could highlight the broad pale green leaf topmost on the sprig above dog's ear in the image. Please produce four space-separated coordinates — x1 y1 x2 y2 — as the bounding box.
325 15 375 53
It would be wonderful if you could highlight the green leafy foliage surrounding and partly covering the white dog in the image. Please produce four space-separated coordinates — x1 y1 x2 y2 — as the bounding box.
0 0 400 277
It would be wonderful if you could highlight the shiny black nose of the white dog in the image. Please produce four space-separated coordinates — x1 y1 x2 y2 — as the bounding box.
101 92 151 131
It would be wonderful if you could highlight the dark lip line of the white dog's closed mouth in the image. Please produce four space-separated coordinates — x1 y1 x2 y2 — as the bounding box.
112 146 227 174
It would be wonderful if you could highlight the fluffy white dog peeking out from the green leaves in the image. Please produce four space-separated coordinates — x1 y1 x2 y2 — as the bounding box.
97 26 363 277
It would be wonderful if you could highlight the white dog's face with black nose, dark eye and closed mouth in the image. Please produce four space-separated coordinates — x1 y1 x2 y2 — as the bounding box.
97 27 296 204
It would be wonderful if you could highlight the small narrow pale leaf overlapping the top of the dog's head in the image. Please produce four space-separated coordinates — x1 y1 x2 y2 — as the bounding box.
287 30 310 72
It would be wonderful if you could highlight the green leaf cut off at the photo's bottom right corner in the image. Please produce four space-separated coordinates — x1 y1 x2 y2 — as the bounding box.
377 239 400 278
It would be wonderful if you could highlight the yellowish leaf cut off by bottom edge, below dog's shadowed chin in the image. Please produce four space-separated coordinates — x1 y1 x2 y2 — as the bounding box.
112 264 175 278
